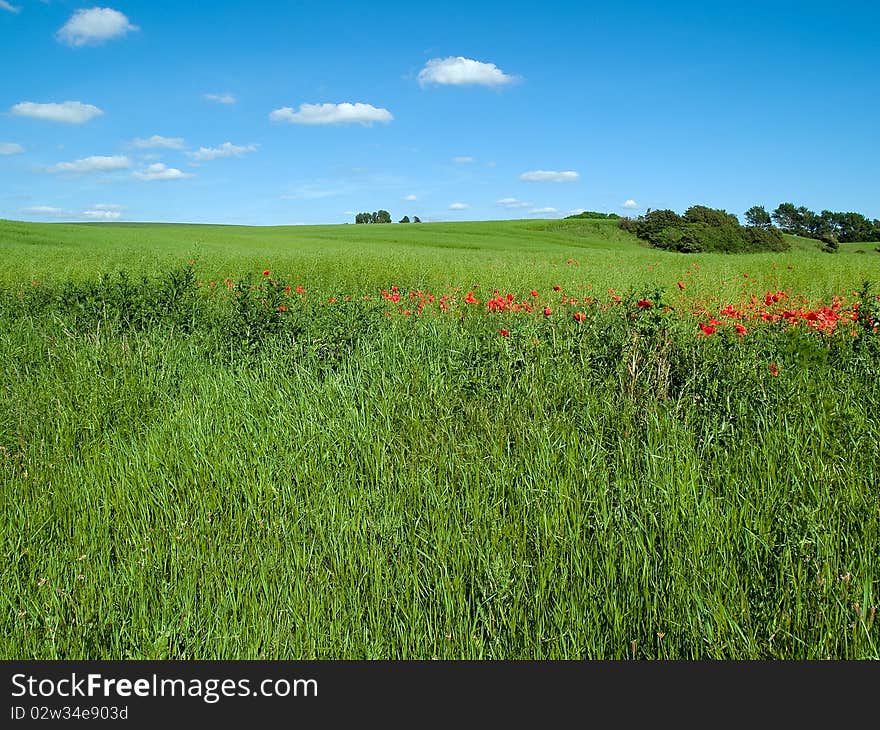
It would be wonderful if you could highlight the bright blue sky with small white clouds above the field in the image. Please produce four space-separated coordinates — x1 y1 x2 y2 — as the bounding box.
0 0 880 225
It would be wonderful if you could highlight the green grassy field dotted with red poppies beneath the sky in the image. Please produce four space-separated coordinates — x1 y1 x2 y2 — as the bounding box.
0 220 880 659
